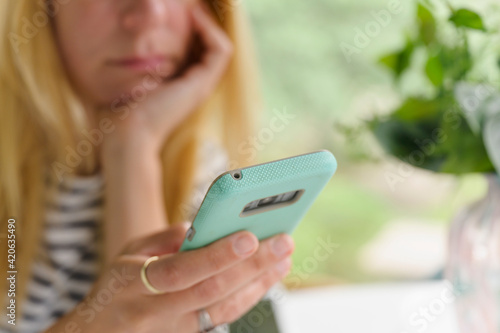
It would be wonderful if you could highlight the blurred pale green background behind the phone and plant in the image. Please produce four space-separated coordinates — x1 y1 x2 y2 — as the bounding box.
239 0 498 288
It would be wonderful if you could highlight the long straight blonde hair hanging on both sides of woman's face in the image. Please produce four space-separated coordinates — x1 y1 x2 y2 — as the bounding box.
0 0 262 318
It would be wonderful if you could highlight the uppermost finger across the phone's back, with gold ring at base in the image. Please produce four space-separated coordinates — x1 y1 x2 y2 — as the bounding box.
143 231 259 294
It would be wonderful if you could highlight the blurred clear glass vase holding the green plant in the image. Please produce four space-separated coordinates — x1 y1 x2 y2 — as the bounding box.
445 174 500 333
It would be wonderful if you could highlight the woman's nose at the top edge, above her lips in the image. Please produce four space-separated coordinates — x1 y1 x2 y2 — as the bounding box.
122 0 169 31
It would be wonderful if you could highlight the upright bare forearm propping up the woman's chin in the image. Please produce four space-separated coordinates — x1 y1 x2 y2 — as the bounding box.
102 144 166 262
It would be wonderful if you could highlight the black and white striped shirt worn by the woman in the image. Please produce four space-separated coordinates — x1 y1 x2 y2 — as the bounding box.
0 141 227 333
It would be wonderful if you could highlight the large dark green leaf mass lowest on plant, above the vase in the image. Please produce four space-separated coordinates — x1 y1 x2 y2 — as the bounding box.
370 96 499 174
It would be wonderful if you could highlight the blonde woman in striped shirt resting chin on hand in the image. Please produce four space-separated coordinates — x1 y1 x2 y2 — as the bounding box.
0 0 293 333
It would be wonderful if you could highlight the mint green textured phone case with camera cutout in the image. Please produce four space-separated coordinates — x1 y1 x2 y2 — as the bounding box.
181 150 337 251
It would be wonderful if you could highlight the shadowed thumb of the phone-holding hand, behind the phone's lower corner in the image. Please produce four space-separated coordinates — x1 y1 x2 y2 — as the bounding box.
121 222 191 256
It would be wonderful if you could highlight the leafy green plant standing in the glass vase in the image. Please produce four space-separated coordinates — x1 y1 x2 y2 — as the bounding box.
356 2 500 174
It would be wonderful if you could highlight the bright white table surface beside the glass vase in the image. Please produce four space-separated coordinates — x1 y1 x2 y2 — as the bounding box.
276 281 458 333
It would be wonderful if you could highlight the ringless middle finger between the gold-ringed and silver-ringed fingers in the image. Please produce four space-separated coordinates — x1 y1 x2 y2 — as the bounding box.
162 234 294 311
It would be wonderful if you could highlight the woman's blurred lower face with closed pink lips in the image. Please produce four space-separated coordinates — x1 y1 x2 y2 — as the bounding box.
54 0 200 105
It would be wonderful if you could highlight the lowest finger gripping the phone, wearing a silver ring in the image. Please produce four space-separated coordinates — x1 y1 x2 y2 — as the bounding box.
183 258 291 332
